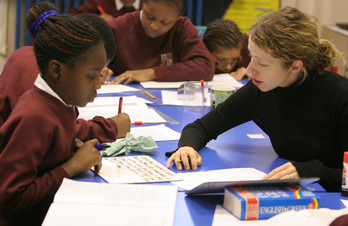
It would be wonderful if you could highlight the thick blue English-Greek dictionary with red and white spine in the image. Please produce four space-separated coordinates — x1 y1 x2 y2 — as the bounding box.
223 184 319 220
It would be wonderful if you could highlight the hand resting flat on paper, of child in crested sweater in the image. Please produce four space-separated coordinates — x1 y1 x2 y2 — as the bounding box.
111 68 156 84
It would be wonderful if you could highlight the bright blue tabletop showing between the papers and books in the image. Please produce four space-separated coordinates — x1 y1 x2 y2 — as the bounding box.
74 84 348 226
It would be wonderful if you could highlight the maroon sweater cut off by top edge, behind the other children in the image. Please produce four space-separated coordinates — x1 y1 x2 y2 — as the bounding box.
68 0 142 17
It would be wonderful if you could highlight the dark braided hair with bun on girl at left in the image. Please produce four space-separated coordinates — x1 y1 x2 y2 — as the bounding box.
27 2 103 74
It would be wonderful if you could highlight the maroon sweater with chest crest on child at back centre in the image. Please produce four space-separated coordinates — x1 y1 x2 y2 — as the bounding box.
108 11 215 81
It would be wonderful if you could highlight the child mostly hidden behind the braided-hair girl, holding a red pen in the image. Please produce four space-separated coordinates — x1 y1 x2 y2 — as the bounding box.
0 13 131 142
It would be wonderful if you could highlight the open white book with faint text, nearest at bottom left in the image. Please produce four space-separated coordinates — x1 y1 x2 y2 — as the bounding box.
42 179 177 226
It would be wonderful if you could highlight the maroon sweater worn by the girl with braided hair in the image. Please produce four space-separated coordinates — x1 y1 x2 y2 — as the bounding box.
0 87 77 225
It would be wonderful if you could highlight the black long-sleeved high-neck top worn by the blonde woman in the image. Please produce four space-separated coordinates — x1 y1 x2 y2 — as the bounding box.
179 72 348 191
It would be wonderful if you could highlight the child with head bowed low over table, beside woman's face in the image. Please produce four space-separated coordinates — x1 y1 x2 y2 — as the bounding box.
203 19 250 80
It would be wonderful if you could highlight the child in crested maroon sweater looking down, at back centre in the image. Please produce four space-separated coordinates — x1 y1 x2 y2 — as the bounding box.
108 0 214 84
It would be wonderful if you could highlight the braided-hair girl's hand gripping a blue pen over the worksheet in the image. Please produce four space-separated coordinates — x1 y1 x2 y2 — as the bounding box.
61 139 102 177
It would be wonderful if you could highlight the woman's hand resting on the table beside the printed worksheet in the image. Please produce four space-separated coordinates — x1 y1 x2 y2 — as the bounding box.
167 146 202 170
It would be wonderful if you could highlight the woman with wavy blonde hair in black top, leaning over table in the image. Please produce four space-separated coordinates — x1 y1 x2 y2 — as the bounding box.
167 7 348 192
